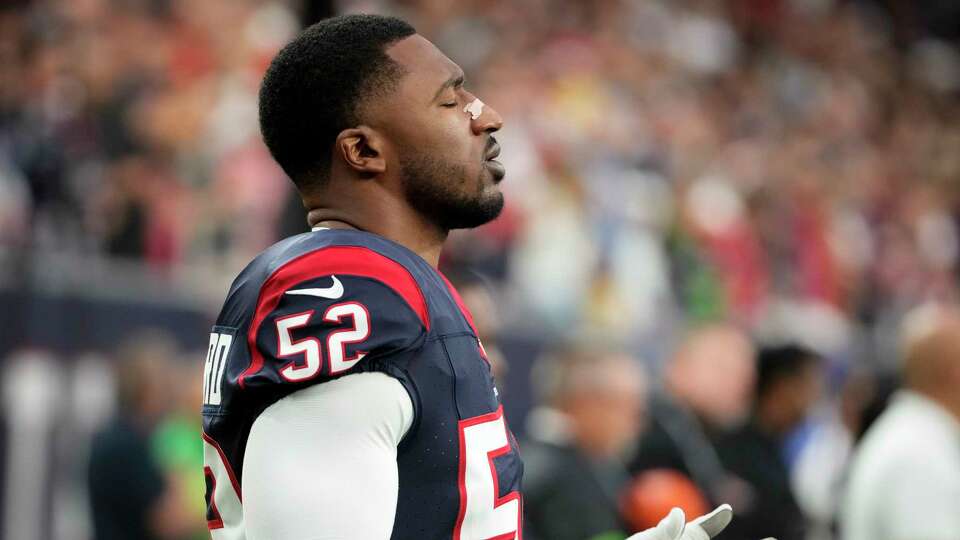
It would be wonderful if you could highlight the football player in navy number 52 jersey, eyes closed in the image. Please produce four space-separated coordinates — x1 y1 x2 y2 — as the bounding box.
203 15 756 540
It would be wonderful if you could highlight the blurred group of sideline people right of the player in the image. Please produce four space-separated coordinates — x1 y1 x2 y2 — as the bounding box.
521 304 960 540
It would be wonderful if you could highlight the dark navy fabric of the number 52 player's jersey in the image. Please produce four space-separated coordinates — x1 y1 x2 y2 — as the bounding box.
203 230 523 539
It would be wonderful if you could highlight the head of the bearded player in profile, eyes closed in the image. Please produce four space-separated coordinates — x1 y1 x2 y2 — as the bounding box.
260 15 503 230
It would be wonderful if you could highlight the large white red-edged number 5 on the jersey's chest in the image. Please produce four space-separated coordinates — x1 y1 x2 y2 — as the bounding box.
453 408 520 540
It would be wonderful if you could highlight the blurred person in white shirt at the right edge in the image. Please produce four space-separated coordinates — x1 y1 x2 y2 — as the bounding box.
841 305 960 540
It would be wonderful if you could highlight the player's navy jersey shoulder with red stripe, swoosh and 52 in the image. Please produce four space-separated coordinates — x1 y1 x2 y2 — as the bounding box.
211 230 431 397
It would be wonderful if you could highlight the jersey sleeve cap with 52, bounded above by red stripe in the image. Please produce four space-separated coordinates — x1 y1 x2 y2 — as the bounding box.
238 246 430 387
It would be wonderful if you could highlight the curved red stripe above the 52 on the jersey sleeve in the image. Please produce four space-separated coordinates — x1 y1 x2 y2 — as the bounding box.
237 246 430 388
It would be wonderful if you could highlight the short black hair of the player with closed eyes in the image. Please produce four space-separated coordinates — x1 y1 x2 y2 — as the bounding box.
260 15 416 192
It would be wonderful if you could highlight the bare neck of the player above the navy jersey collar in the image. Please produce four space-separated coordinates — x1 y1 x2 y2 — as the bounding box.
307 208 448 268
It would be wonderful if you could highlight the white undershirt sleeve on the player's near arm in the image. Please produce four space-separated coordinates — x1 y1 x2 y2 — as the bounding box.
243 373 414 540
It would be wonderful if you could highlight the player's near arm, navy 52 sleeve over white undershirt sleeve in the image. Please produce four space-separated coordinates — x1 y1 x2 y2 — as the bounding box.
238 251 429 540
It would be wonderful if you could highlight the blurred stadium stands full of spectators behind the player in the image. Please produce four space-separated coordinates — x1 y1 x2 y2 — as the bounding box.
0 0 960 540
